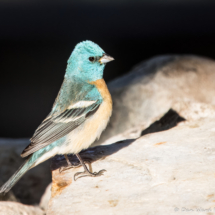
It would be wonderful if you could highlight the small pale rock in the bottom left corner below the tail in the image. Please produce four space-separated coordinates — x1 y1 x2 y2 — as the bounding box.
0 202 45 215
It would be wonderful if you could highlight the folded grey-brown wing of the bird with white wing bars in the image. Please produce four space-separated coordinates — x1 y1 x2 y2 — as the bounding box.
21 79 102 157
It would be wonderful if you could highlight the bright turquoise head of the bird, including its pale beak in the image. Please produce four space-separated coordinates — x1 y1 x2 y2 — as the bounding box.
65 41 114 82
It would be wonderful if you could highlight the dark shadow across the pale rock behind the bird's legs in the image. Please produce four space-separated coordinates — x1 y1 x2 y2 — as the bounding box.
51 109 185 171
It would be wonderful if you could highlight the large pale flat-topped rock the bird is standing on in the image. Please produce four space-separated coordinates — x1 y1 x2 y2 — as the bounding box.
47 103 215 215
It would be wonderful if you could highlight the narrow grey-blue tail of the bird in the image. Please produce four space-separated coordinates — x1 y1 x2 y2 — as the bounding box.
0 158 32 193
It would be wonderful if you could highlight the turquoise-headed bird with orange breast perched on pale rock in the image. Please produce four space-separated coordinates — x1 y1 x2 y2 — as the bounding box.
0 40 114 193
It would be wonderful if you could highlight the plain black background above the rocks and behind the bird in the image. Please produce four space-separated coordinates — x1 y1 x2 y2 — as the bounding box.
0 0 215 138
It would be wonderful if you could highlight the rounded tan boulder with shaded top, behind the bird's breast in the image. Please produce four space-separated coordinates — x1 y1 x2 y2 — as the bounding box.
93 55 215 146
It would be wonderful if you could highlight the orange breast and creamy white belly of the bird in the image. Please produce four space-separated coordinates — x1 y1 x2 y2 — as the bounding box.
34 79 112 166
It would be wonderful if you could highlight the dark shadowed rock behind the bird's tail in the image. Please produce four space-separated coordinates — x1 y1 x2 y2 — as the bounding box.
0 139 51 204
